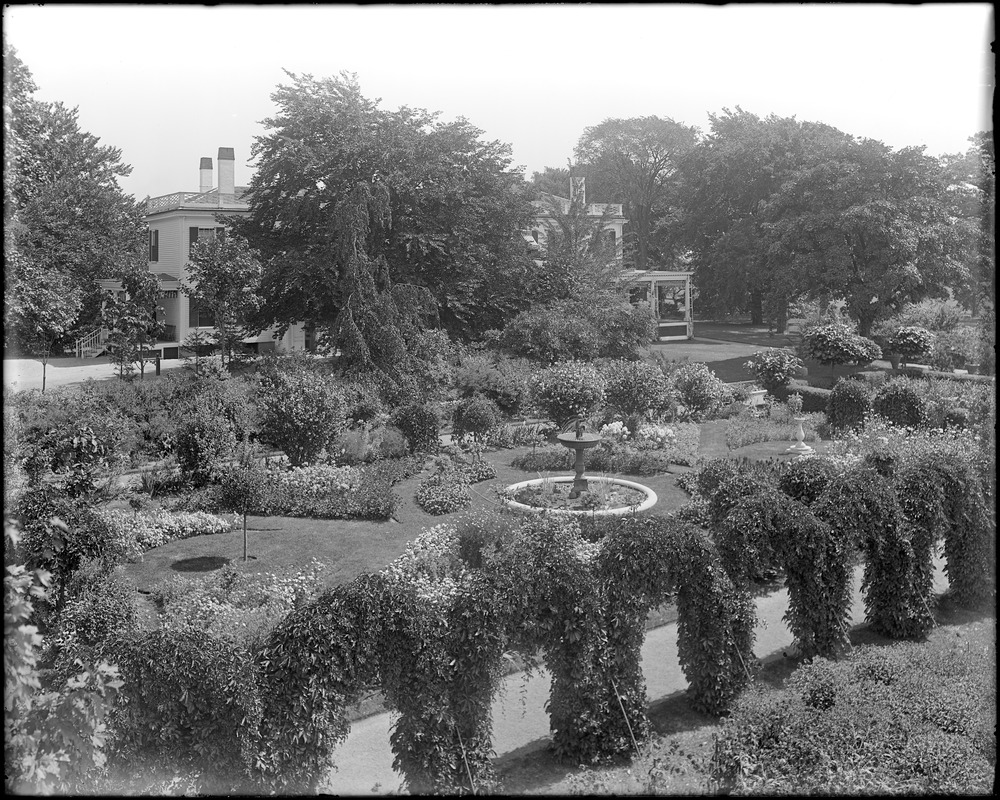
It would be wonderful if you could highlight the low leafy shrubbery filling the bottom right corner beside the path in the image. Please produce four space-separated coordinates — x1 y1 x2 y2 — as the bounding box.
711 623 996 795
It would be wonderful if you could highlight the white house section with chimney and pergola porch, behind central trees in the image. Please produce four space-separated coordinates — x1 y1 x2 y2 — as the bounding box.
525 178 694 342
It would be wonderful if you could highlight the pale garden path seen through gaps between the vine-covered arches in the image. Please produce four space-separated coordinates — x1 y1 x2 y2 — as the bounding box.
320 560 948 795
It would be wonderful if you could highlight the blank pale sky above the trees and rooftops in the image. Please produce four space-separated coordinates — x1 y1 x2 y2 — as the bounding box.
3 3 994 203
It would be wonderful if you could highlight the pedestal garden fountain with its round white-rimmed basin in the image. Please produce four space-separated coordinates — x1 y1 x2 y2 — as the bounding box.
503 418 657 516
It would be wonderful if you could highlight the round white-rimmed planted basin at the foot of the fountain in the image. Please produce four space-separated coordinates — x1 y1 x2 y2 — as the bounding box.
501 475 657 516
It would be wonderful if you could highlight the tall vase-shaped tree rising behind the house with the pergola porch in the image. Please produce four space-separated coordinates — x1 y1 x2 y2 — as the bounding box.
575 116 697 270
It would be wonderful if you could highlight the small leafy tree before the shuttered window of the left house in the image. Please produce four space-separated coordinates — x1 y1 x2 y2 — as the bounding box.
181 233 263 364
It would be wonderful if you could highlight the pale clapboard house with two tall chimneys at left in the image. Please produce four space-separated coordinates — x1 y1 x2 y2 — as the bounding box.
77 147 311 358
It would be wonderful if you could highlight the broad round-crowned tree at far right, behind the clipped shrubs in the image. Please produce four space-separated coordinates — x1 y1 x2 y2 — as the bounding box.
765 138 972 335
